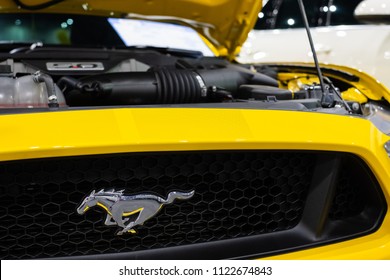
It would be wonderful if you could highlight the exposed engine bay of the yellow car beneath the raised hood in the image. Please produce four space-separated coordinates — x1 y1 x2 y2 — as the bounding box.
0 47 386 115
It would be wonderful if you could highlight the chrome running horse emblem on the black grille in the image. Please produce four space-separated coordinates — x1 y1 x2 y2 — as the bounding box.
77 190 195 235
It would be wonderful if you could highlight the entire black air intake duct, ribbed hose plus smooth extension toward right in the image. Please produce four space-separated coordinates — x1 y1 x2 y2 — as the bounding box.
59 67 277 106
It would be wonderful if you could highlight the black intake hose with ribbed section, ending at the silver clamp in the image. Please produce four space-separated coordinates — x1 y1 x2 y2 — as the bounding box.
63 69 207 106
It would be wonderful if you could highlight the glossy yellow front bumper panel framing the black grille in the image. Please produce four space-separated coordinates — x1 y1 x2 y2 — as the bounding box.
0 108 390 259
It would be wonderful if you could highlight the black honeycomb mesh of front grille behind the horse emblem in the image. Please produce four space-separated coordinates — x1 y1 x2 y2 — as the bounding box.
0 151 384 259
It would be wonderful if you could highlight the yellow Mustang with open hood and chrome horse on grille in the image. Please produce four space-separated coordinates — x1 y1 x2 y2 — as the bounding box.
0 0 390 259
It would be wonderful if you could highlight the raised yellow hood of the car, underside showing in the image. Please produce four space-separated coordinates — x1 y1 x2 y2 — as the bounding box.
0 0 262 58
